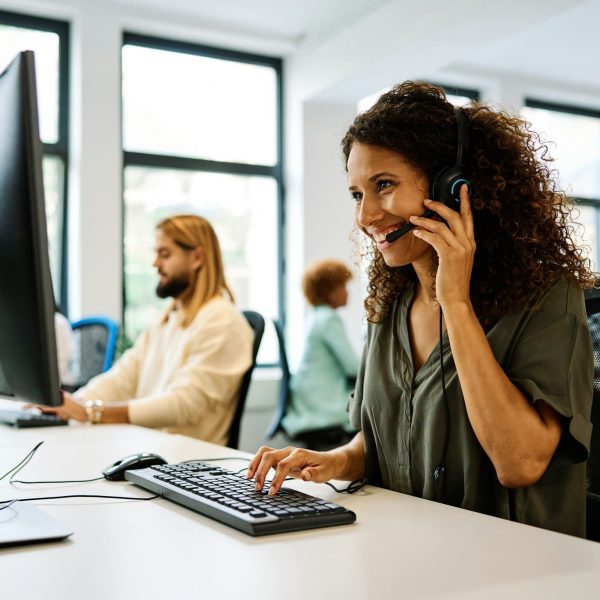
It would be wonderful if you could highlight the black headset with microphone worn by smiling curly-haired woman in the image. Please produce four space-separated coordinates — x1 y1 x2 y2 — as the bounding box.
385 106 471 244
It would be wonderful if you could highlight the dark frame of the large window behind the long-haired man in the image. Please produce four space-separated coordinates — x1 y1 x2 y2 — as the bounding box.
121 31 286 368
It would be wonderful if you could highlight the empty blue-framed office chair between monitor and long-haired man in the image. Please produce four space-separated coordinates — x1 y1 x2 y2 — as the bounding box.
71 317 119 388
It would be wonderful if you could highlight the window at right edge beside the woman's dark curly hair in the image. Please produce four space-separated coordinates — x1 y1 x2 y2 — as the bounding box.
522 100 600 269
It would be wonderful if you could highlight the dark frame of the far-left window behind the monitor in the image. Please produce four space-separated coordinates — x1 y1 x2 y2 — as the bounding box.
0 10 71 314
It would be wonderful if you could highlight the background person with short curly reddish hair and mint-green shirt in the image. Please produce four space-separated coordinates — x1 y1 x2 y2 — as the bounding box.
282 259 358 450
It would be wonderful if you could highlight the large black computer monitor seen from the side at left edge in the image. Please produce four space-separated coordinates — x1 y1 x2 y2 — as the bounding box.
0 51 61 406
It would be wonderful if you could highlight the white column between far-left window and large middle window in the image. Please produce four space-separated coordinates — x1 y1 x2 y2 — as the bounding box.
69 3 122 319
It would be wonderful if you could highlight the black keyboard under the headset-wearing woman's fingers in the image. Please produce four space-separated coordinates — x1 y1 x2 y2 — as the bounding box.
125 462 356 535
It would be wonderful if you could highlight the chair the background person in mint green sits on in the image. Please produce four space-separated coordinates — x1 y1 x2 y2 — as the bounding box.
265 321 354 450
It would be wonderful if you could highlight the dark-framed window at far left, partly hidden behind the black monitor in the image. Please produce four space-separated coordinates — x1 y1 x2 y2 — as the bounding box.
0 11 69 310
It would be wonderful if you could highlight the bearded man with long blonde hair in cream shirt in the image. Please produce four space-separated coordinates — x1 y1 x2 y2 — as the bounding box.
44 215 253 444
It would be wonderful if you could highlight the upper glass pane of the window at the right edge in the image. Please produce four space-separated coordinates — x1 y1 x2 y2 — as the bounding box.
522 107 600 198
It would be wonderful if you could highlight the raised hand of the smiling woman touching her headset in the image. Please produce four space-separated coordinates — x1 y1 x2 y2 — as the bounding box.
410 184 475 311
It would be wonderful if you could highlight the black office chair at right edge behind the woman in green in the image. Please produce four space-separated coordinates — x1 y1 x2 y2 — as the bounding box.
585 288 600 542
